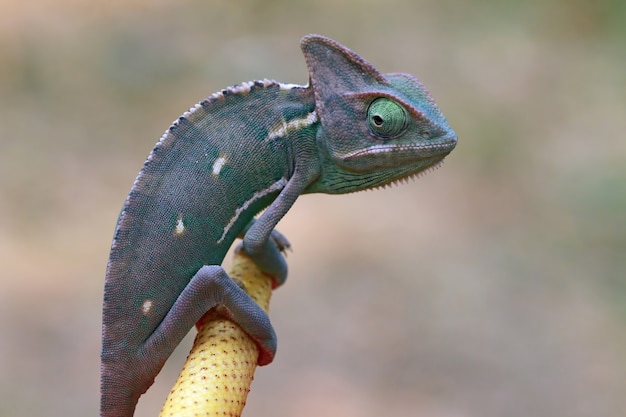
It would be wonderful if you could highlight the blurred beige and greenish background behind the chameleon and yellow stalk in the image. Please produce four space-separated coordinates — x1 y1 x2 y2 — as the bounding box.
0 0 626 417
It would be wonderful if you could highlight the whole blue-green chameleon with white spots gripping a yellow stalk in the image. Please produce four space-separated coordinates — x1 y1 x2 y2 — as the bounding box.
100 35 457 417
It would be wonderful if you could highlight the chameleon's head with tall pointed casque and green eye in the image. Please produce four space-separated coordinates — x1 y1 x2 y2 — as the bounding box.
301 35 457 194
